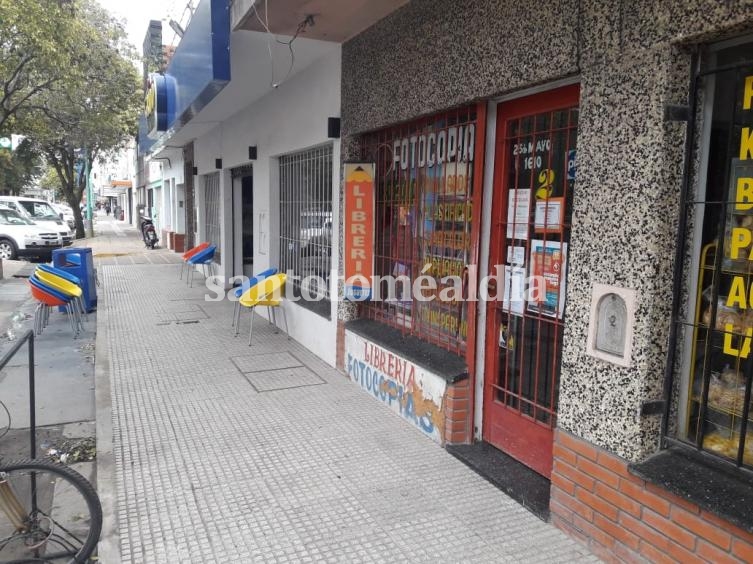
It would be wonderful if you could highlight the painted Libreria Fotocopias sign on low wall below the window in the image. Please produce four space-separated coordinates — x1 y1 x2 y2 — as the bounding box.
345 331 447 443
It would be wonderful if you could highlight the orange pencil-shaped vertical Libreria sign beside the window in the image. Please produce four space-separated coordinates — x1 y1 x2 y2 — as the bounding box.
344 163 375 300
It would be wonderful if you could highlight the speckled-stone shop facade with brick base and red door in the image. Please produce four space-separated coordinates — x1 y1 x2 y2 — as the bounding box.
338 0 753 561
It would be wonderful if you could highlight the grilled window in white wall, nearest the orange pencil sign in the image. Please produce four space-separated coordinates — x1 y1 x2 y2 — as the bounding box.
279 144 333 310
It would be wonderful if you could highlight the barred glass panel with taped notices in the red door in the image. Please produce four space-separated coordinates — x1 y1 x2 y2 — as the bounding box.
491 93 578 428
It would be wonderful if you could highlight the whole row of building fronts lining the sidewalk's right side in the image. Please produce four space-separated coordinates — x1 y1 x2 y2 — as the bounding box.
141 0 753 562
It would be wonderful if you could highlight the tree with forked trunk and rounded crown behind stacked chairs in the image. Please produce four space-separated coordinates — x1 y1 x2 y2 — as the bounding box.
24 0 142 237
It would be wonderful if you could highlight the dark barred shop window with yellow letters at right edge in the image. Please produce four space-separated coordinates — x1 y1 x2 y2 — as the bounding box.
662 39 753 471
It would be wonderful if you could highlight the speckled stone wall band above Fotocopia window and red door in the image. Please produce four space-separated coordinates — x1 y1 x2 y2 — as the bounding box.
342 0 579 135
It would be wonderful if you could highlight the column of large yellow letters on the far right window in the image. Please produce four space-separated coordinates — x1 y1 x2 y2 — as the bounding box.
723 76 753 359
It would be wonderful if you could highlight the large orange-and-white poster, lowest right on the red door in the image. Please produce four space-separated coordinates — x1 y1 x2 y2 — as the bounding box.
528 239 567 319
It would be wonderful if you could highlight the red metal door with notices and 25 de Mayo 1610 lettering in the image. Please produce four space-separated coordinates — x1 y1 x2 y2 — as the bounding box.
483 85 579 477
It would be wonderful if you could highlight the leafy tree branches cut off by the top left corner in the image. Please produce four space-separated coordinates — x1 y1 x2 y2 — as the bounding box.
0 0 78 133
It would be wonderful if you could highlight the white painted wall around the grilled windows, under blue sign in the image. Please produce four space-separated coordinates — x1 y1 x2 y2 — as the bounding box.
194 49 340 365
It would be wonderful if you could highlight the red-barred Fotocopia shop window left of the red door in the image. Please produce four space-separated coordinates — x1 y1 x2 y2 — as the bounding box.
361 106 483 354
